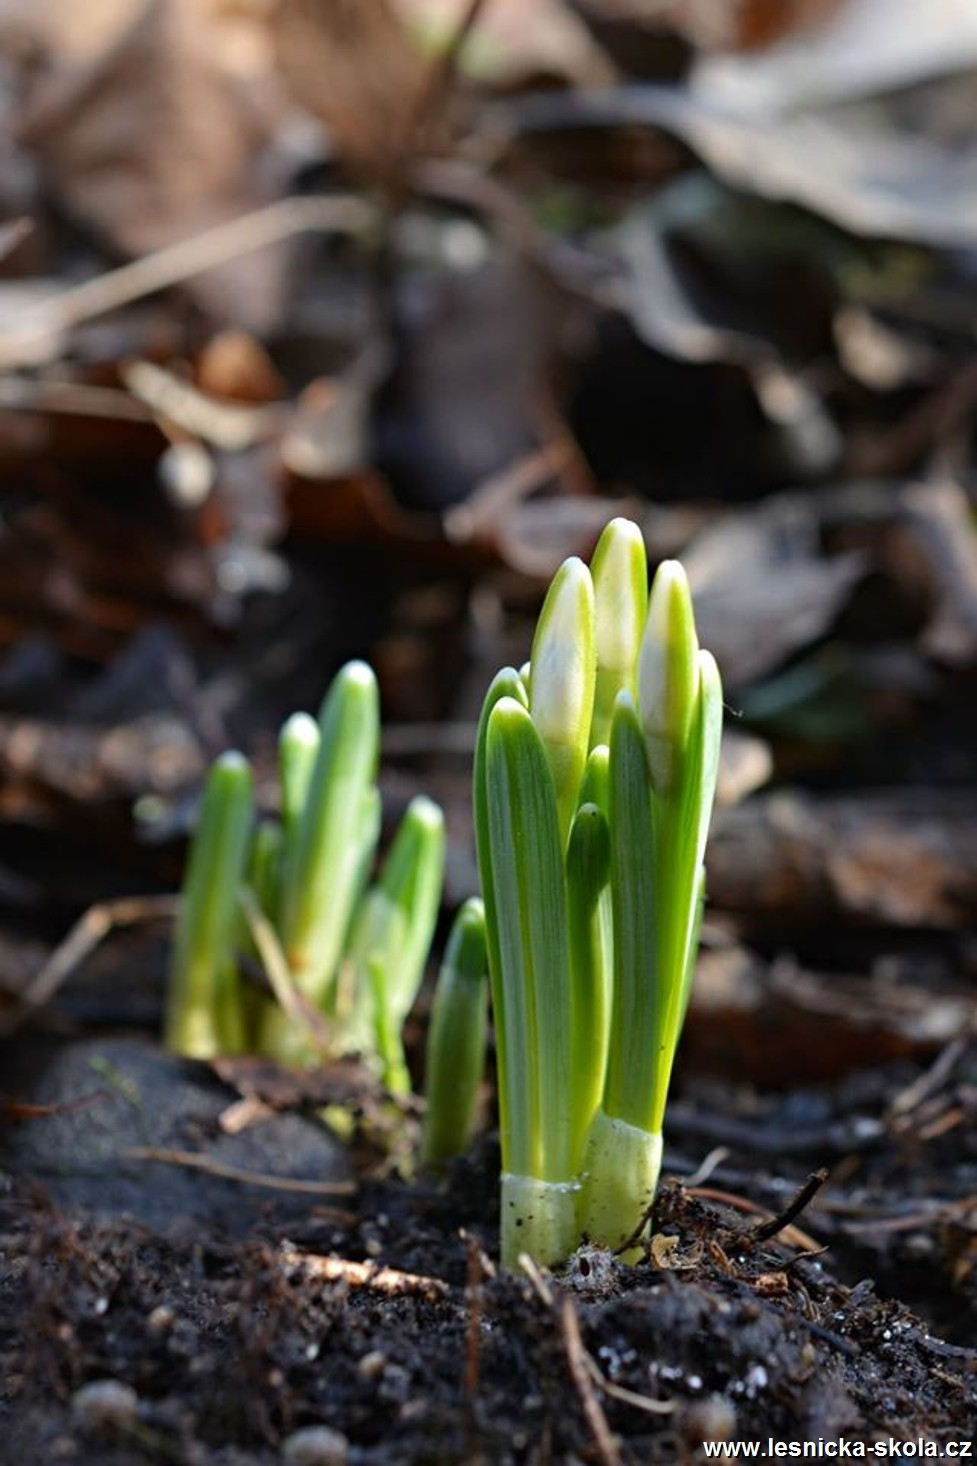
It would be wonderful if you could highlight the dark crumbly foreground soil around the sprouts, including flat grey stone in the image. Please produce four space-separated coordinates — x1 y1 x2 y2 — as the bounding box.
0 1014 977 1466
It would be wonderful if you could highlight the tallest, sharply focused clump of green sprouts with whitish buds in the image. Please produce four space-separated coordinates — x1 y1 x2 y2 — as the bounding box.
474 519 722 1264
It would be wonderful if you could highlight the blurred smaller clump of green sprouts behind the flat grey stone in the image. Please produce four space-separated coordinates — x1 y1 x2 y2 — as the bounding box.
166 661 444 1094
